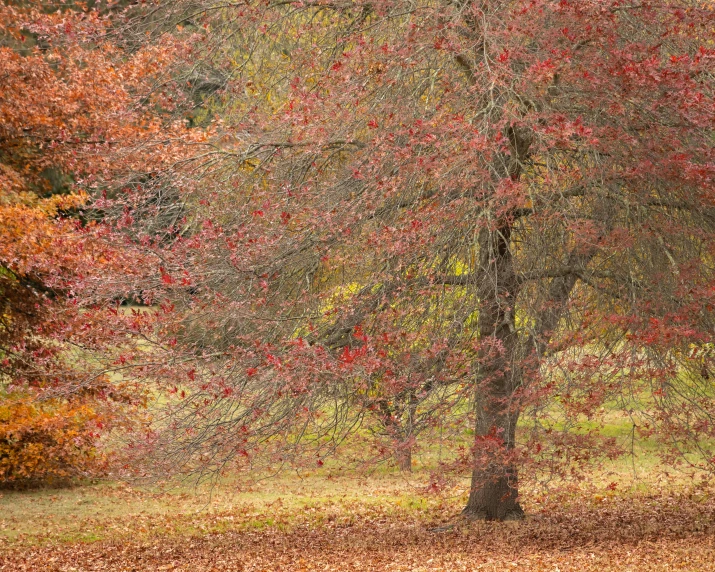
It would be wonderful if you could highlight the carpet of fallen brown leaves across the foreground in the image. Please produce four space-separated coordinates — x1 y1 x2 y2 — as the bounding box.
0 488 715 572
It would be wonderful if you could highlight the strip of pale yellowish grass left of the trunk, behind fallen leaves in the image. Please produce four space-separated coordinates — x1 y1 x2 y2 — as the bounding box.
0 472 444 545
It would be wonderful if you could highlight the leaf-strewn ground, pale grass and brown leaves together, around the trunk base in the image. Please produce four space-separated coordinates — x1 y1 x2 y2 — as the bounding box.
0 456 715 572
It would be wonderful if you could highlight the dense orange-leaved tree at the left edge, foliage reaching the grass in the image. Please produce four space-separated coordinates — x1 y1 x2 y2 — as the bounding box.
0 2 193 484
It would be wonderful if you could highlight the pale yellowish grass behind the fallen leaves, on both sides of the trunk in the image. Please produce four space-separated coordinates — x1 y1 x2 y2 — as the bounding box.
0 444 704 546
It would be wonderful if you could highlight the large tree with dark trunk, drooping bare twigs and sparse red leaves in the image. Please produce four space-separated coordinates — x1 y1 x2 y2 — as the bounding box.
124 0 715 520
